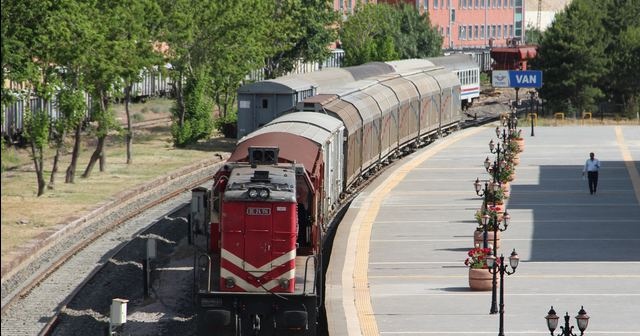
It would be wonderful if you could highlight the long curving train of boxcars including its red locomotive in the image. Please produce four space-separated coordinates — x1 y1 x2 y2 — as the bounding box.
189 53 478 336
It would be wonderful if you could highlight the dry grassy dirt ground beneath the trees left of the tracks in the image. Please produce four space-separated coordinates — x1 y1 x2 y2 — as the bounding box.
0 99 235 274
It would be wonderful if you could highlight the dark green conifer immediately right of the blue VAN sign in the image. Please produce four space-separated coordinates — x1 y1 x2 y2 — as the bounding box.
533 0 609 111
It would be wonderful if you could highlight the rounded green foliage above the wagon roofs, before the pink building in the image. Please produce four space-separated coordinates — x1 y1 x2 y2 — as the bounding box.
340 3 442 65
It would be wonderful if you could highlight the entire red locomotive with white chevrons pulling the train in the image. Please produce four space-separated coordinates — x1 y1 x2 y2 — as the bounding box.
192 147 318 335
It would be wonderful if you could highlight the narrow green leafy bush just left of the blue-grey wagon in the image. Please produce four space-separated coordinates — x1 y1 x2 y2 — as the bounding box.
171 71 213 147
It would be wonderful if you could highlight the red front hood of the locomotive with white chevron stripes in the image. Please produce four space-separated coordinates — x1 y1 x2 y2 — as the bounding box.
220 165 297 293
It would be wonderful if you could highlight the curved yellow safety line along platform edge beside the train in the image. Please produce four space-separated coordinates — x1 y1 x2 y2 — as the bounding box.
353 127 487 336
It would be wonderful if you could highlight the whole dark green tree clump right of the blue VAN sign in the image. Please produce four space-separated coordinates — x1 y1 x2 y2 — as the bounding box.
532 0 640 117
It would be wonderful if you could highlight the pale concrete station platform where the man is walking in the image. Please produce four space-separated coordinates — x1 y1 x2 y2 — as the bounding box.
325 124 640 336
